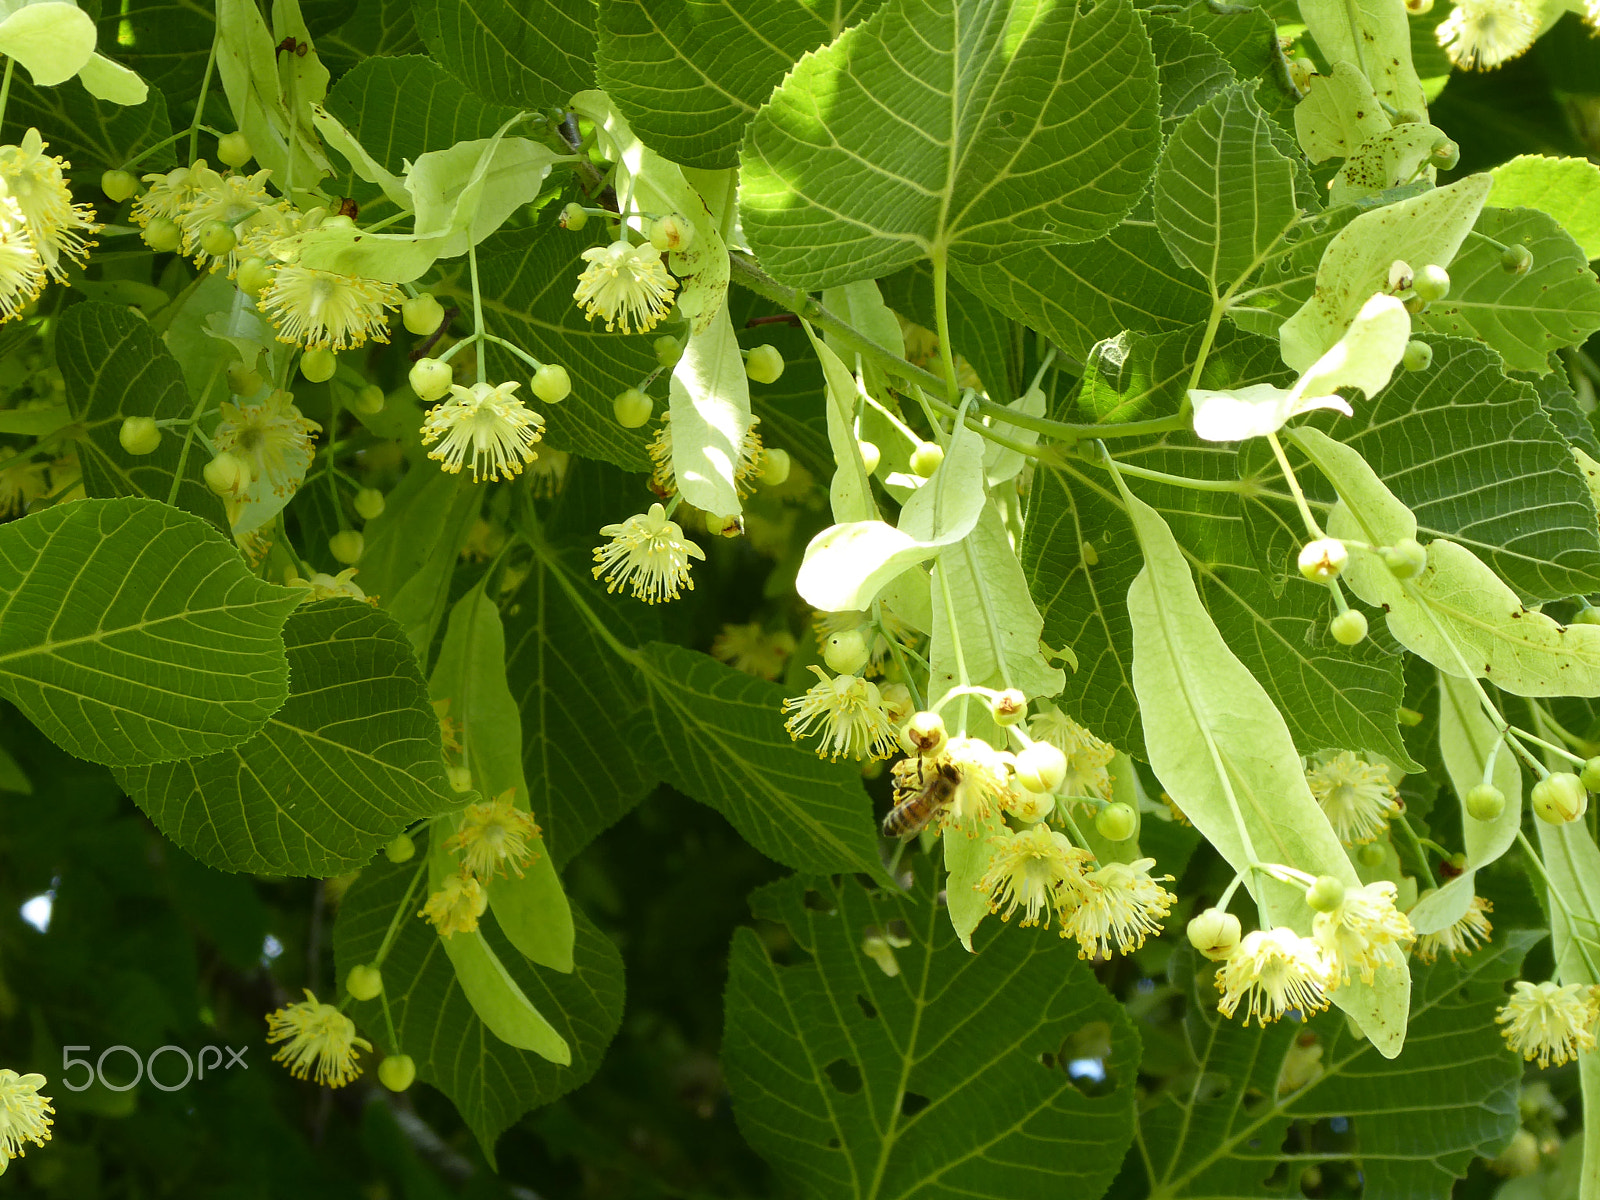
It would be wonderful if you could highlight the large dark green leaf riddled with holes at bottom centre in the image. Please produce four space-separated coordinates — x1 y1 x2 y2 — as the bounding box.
723 878 1138 1200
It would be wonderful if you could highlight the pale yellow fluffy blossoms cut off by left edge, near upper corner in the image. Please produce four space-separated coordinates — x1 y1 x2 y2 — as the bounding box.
0 130 99 320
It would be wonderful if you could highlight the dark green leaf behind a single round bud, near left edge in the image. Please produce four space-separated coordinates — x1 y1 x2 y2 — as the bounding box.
56 301 227 531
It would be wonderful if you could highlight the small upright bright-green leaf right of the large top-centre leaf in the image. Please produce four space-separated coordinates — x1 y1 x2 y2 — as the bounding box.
1155 83 1299 293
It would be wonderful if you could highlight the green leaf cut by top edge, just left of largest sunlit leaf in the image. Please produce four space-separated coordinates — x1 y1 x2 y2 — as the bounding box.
597 0 877 168
